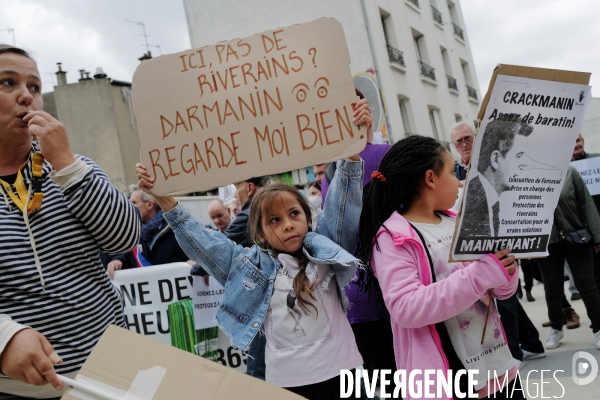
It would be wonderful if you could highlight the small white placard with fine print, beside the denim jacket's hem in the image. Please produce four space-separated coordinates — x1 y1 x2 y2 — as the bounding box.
192 276 225 329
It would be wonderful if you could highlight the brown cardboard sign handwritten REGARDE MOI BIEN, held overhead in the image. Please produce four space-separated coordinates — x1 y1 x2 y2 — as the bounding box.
133 18 366 195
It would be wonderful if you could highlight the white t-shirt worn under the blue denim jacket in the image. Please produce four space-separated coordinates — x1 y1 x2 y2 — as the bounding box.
264 254 363 387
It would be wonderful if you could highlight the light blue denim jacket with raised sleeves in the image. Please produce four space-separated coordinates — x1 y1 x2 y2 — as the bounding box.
164 160 363 349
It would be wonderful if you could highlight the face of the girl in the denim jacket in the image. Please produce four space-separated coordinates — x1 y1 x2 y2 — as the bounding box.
261 192 308 253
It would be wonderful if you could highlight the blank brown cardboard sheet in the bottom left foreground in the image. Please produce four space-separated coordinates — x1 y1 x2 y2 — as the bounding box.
62 326 303 400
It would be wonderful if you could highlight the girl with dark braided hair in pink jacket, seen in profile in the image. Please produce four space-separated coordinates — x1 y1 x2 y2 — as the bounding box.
357 136 524 399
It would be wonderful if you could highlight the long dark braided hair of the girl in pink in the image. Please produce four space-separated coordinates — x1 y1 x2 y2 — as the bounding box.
356 135 446 298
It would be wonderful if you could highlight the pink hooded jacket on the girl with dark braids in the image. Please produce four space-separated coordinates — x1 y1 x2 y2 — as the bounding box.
372 211 519 394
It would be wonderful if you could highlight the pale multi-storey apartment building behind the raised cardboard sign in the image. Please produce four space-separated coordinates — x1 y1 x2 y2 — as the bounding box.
184 0 483 155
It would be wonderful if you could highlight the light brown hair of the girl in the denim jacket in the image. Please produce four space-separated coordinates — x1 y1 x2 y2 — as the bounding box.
248 183 318 313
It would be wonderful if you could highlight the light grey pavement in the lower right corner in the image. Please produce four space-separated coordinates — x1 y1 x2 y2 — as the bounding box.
520 279 600 400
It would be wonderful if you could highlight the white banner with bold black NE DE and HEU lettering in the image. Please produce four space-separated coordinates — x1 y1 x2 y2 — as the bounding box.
112 263 247 371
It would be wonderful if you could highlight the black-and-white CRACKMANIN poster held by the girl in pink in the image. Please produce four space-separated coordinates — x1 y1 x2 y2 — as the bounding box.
450 65 590 261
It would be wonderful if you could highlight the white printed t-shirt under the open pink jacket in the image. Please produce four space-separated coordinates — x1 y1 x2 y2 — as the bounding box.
412 215 515 390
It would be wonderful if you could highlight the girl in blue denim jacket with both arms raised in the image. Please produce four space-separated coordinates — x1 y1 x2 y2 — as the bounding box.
136 156 363 400
